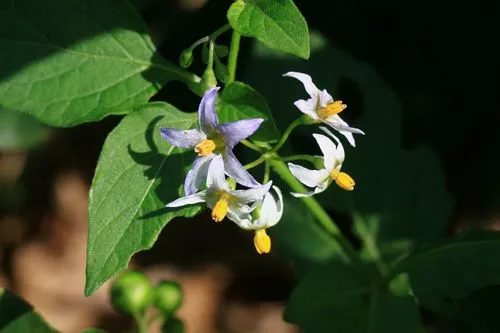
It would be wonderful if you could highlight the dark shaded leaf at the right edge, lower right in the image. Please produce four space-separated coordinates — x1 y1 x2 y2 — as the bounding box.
400 231 500 312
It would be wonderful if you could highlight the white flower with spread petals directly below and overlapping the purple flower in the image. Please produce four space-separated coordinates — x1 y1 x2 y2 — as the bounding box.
166 155 272 224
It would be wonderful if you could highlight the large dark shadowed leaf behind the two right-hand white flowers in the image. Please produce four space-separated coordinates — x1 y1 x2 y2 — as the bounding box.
244 32 453 257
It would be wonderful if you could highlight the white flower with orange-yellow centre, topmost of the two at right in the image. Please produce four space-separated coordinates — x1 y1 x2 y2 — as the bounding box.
283 72 365 147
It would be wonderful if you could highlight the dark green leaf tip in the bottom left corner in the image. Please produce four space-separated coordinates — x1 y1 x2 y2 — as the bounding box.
0 288 56 333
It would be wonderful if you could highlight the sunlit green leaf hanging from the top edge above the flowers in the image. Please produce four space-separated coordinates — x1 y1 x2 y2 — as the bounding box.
227 0 309 59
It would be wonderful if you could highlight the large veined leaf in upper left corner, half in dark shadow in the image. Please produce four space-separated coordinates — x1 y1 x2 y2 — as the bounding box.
0 0 194 127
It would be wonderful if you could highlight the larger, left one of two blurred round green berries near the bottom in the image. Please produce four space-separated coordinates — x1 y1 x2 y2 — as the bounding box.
111 271 153 315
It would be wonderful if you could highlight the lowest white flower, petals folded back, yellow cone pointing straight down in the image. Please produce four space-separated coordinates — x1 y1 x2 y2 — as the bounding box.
233 186 283 254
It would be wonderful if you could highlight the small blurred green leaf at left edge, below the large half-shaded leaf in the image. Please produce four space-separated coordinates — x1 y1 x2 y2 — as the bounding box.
0 108 50 150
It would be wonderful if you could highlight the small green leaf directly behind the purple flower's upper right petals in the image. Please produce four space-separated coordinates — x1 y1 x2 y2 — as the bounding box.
217 82 280 141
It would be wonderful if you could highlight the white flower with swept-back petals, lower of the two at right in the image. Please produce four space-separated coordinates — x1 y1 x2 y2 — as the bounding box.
288 127 356 197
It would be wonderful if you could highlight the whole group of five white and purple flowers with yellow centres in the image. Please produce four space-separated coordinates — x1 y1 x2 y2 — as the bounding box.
160 72 364 254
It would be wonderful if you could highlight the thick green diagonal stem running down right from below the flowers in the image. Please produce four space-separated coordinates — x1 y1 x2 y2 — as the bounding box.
268 159 363 266
